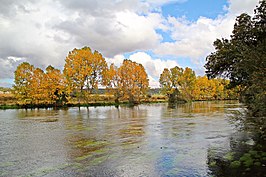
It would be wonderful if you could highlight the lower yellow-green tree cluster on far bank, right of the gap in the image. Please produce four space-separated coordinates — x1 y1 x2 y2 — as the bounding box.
159 66 239 102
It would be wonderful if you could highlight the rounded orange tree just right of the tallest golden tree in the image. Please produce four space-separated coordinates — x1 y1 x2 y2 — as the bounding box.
117 60 149 103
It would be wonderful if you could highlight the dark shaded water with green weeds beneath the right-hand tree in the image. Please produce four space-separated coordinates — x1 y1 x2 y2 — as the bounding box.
208 109 266 177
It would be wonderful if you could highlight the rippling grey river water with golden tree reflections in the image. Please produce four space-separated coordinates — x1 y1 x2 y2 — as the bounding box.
0 101 241 177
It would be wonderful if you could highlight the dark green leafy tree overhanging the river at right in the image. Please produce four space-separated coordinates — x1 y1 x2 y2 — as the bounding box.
205 1 266 116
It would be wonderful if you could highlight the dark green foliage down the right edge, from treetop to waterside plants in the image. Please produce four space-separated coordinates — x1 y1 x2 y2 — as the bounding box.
205 0 266 177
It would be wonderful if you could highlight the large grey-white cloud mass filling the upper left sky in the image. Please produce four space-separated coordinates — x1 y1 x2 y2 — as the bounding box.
0 0 166 86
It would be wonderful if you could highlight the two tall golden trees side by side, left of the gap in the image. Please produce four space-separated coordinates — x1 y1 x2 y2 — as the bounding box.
64 47 149 103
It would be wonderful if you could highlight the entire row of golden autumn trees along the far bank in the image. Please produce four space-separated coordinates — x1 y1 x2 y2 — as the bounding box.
14 47 239 104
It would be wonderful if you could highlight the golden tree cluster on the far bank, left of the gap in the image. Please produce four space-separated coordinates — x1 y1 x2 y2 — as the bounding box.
14 47 149 104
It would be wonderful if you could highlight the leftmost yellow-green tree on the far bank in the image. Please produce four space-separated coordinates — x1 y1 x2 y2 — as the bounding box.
14 62 34 103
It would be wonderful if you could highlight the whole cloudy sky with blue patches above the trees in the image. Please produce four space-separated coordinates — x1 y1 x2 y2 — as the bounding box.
0 0 259 87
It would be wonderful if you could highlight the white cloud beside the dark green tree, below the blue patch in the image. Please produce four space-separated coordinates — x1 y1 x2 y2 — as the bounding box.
154 0 259 73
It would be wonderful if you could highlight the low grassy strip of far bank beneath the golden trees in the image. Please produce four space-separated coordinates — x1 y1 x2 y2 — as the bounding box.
0 89 237 110
